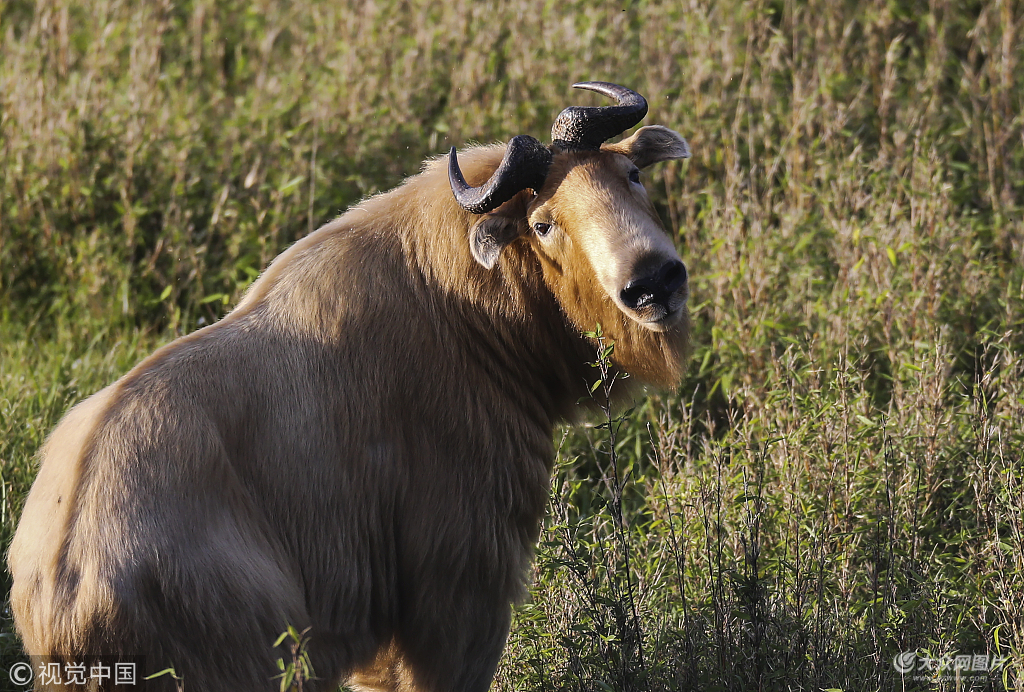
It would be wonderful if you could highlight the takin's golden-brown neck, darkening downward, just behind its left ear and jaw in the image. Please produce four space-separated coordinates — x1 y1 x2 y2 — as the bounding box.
402 198 595 425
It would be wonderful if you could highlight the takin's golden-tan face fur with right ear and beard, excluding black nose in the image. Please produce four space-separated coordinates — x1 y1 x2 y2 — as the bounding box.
528 126 689 387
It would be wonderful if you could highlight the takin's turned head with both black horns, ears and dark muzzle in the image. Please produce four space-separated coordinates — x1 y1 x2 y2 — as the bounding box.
449 82 690 384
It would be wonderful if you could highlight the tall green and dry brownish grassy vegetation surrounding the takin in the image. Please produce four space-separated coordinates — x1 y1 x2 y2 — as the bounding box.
0 0 1024 691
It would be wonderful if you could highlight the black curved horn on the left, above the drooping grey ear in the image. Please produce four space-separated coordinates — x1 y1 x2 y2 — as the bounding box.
449 134 551 214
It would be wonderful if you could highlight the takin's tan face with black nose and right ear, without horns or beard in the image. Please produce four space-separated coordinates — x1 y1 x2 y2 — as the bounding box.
527 126 689 332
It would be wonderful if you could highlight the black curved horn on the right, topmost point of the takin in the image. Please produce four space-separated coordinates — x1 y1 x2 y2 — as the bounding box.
551 82 647 152
